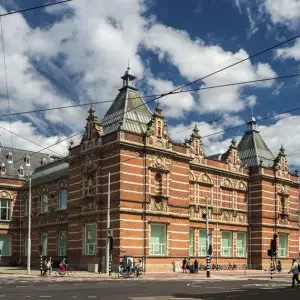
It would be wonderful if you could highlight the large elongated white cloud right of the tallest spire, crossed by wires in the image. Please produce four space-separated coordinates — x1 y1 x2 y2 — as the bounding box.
145 24 276 112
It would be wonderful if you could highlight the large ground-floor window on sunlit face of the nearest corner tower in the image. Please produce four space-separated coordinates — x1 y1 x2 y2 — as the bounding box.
150 224 167 256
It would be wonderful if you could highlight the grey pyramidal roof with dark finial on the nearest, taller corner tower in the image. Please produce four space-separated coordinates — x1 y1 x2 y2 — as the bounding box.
101 68 152 134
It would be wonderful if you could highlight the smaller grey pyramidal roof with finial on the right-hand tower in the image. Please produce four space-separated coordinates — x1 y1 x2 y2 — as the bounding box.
238 116 274 168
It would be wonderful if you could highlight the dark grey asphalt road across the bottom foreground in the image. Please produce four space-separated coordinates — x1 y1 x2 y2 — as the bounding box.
0 278 300 300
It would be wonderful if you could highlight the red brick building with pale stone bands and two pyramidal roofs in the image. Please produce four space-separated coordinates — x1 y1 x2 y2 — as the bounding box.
0 71 300 271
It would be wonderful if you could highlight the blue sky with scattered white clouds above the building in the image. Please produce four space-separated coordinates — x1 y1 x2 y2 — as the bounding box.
0 0 300 167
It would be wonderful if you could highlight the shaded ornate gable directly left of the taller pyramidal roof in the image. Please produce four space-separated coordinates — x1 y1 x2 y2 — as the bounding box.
81 105 104 151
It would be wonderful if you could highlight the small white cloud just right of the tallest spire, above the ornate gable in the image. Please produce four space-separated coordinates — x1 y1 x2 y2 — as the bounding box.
148 78 195 118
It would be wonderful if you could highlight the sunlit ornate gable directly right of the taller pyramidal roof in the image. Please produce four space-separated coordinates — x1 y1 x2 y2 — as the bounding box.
146 104 172 149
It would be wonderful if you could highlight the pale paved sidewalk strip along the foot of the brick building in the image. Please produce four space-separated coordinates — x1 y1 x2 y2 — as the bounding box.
0 267 289 280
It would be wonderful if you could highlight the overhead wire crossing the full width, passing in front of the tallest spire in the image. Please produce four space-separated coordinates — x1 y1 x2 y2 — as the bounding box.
0 73 300 122
